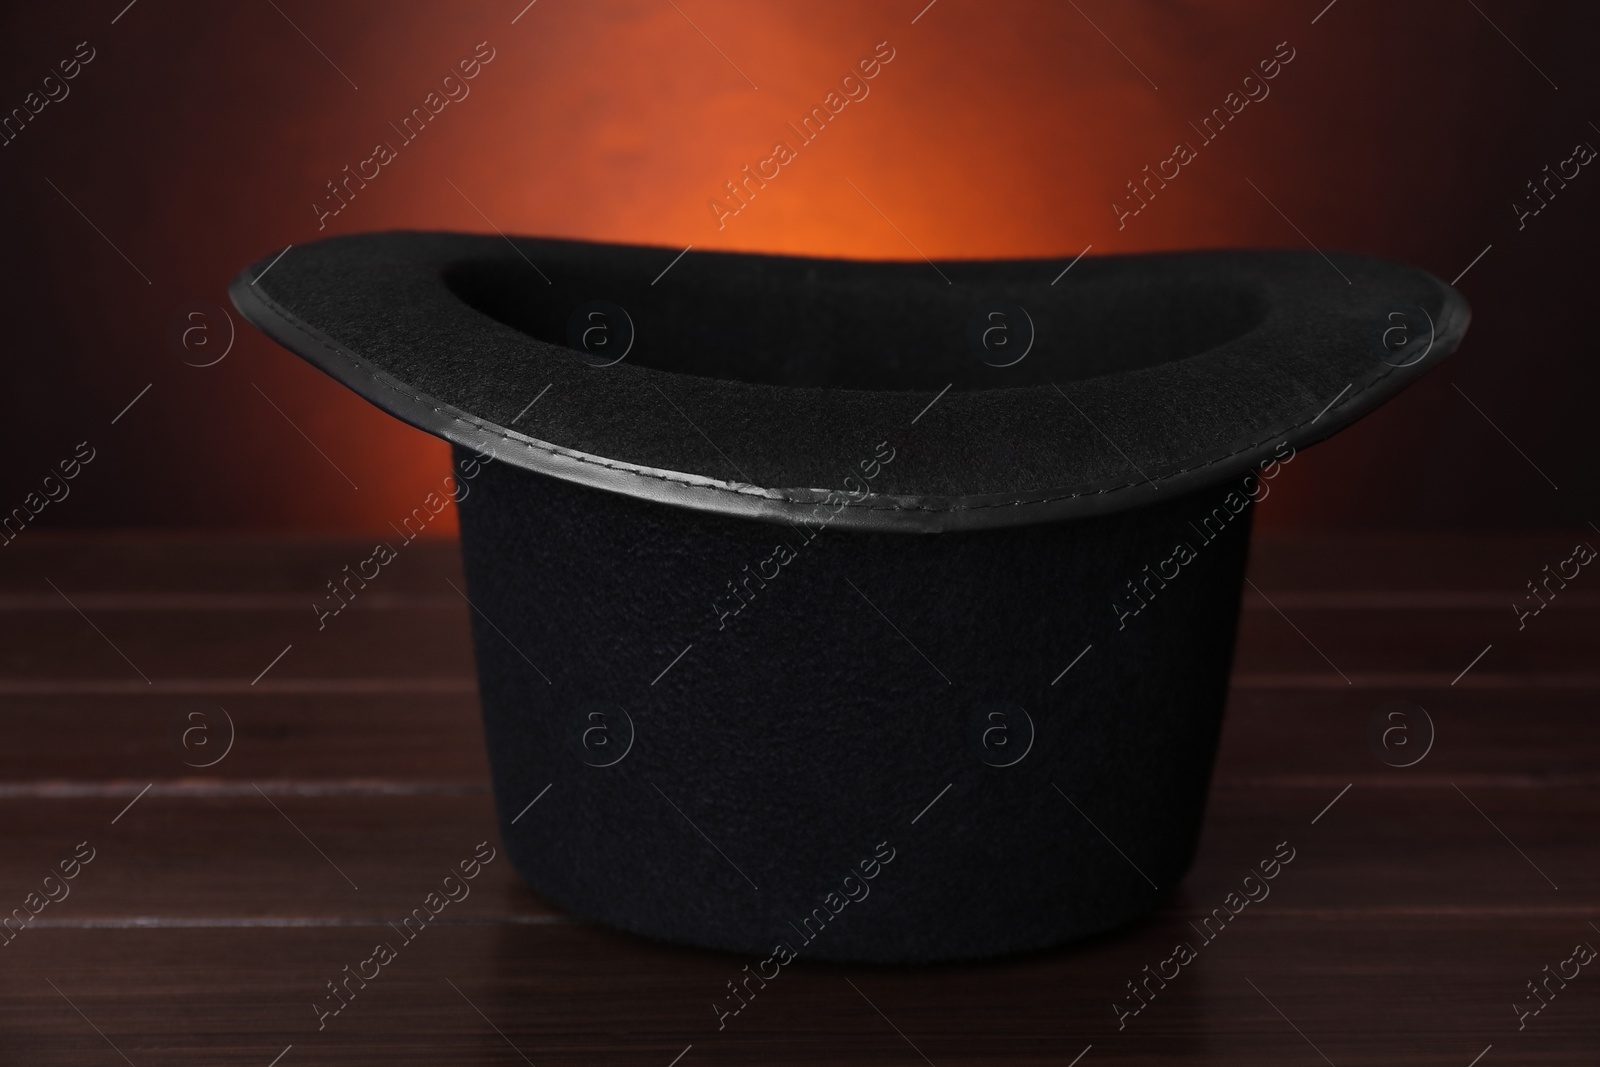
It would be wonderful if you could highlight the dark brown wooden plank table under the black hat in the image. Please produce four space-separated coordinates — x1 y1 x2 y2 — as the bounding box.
0 530 1600 1067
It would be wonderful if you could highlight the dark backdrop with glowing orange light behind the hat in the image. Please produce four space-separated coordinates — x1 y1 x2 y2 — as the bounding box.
0 0 1600 533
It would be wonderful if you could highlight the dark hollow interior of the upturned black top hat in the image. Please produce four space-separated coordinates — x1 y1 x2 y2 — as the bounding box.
443 258 1269 392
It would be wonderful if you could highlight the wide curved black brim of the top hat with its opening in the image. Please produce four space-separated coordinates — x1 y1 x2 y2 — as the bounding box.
230 232 1467 533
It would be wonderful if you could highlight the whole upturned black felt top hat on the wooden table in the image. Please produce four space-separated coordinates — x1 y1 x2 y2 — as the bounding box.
232 234 1467 960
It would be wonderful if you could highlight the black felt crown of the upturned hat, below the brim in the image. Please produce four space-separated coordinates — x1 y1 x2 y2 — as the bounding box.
458 451 1250 966
